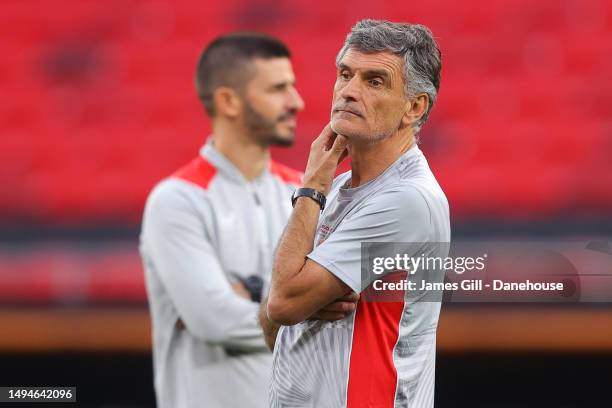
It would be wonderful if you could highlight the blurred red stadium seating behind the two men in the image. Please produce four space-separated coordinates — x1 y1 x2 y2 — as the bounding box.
0 0 612 224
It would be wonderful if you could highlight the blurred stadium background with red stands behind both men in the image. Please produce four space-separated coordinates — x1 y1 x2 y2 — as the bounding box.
0 0 612 408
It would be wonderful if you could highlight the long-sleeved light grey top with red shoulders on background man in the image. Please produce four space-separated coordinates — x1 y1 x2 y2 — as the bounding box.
140 141 301 408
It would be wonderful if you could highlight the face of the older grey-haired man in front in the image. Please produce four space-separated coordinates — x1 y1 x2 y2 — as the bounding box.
331 49 409 142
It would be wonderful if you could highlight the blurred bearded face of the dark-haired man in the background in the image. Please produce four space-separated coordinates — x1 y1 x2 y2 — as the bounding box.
243 58 304 146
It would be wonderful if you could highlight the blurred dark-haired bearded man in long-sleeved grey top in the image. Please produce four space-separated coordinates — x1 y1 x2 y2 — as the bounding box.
140 33 304 408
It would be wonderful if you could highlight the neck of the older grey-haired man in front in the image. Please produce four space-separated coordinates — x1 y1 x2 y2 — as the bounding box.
349 132 415 188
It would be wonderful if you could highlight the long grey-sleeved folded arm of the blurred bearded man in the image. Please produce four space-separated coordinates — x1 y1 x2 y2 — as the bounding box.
141 180 266 351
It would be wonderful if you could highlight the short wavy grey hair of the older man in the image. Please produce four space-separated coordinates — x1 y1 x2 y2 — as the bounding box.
336 20 442 133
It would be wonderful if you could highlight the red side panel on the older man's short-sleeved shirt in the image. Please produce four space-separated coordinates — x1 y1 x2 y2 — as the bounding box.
346 274 405 408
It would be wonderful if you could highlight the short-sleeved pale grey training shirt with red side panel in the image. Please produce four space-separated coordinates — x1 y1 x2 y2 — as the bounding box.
270 146 450 408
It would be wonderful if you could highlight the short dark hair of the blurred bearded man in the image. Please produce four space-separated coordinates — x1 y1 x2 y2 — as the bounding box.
195 32 291 117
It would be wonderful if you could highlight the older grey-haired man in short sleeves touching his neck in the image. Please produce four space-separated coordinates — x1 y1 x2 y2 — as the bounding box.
260 20 450 408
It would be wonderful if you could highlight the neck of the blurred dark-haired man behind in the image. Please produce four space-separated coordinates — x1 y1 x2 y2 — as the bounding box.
213 124 270 181
